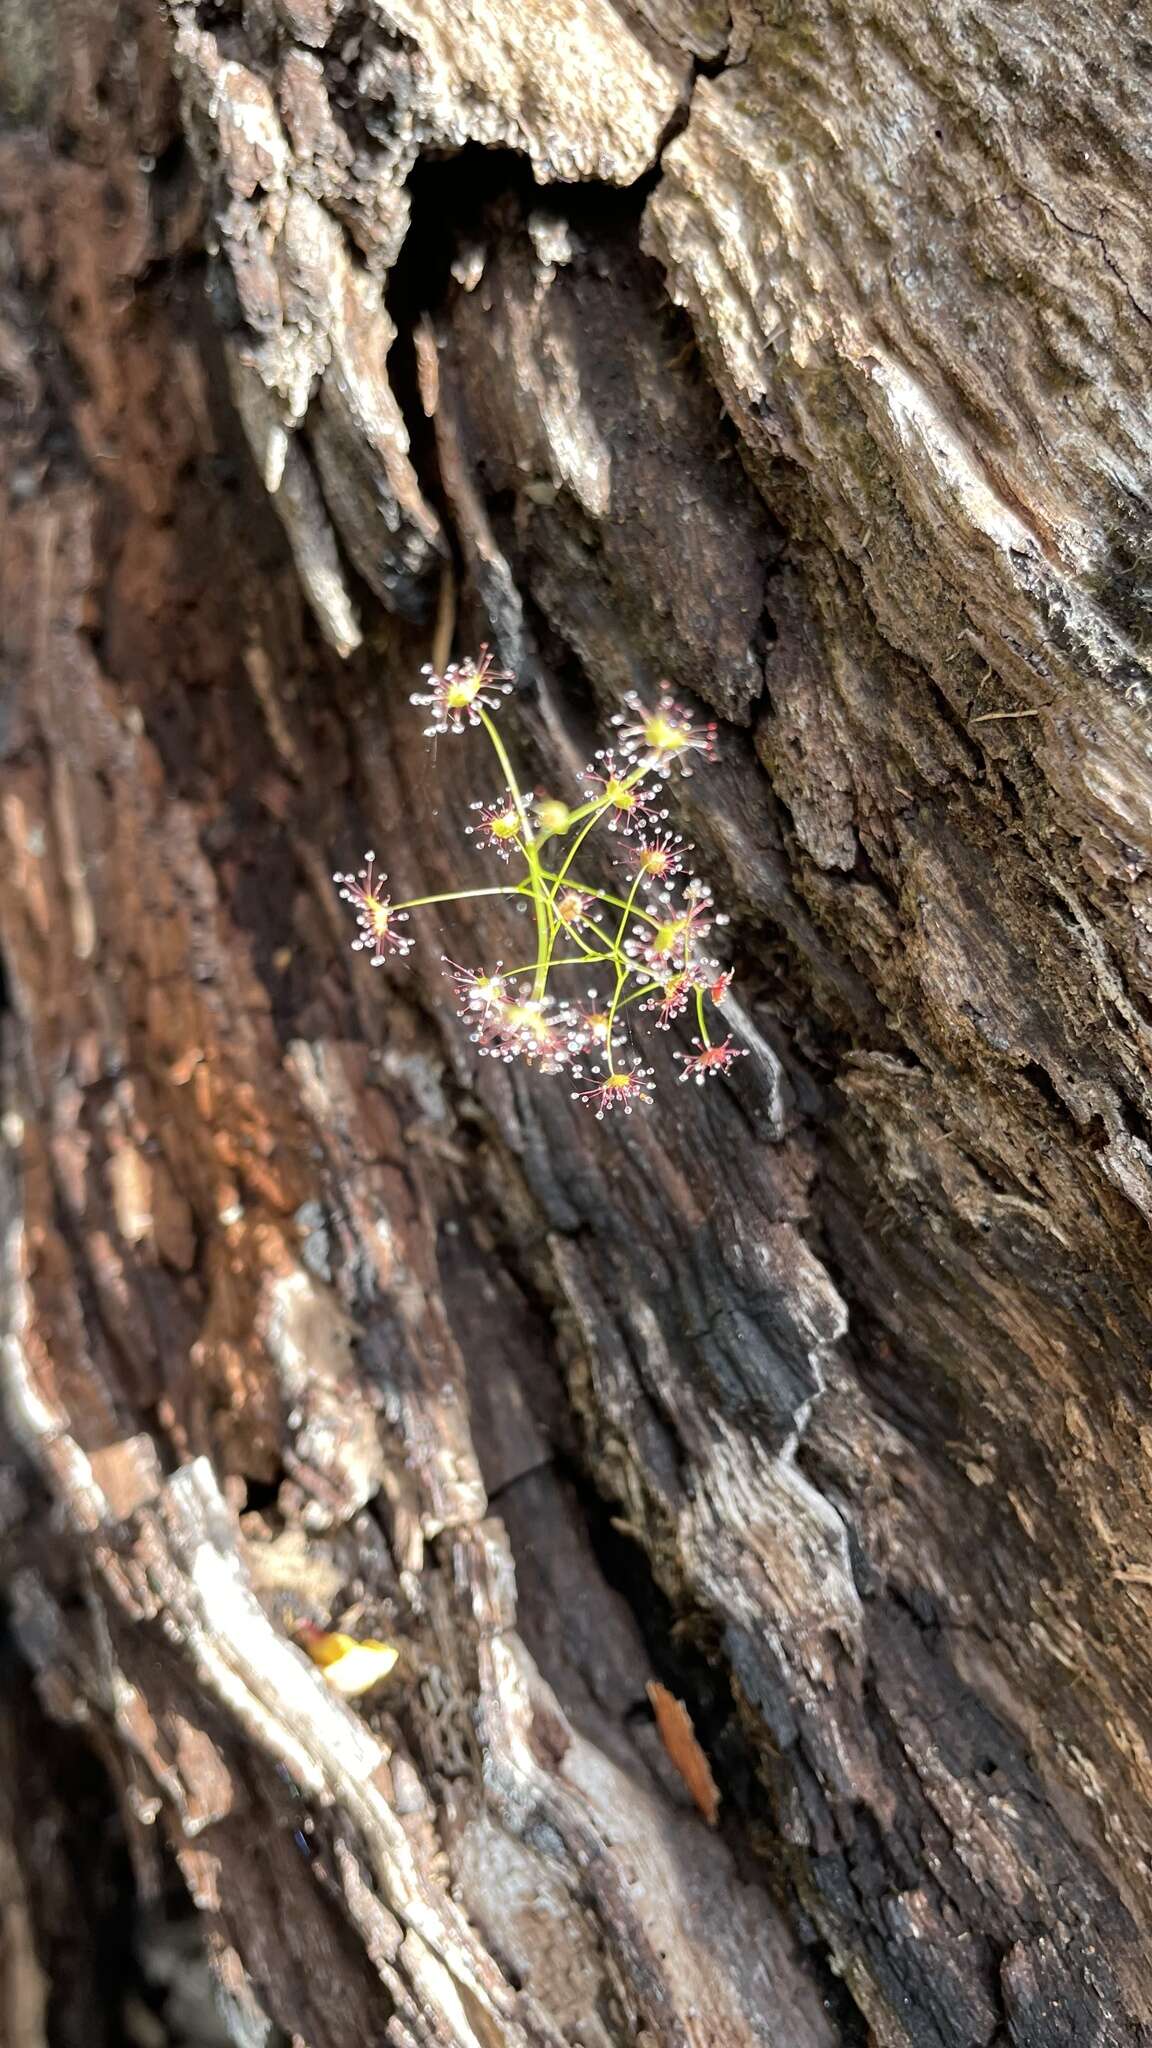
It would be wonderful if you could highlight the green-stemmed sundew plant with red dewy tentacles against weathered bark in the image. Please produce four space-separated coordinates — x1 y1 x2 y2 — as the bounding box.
334 647 742 1118
